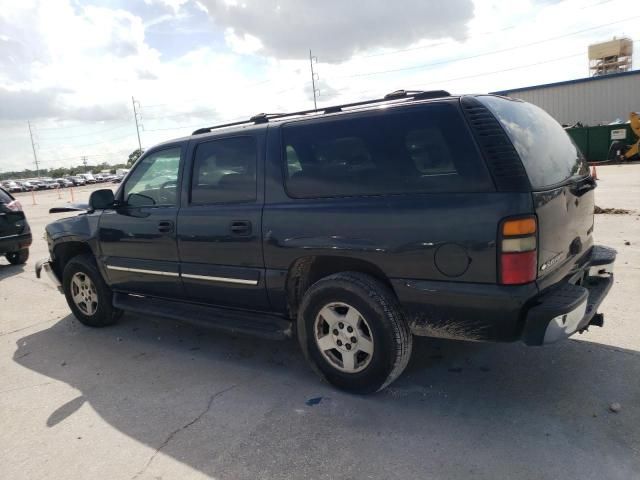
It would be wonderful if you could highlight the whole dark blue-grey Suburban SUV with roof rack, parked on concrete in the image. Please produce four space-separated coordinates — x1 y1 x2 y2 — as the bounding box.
37 91 615 393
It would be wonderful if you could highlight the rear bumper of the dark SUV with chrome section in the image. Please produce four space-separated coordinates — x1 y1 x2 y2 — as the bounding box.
522 246 616 345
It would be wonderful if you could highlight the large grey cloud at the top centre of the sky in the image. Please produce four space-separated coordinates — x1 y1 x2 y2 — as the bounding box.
201 0 473 61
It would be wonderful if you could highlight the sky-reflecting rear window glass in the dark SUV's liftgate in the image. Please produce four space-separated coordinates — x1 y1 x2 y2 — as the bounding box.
478 96 589 188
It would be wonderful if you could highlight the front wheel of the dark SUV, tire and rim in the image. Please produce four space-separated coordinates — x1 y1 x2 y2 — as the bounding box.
62 254 121 327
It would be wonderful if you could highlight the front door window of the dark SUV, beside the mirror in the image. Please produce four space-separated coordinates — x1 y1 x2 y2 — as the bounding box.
124 148 180 207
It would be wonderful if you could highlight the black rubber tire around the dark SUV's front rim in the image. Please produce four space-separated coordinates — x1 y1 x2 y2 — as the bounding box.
62 254 122 327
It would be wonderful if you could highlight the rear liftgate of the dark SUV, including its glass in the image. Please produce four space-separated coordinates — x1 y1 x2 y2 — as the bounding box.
478 96 596 288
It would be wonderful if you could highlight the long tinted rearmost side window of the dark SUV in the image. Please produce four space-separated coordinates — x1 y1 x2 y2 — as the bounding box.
283 104 493 198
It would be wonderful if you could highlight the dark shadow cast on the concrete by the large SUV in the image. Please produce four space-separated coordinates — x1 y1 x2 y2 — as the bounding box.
13 315 640 479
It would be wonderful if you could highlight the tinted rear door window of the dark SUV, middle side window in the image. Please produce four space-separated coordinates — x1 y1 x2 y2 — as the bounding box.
191 137 257 204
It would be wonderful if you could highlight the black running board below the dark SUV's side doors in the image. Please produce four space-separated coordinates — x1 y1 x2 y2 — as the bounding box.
113 292 292 340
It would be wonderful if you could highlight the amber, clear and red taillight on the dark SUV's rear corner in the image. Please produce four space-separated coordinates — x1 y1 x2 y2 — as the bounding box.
499 216 538 285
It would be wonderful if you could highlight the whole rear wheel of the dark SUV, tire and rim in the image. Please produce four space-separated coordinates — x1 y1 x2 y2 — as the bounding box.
298 272 412 393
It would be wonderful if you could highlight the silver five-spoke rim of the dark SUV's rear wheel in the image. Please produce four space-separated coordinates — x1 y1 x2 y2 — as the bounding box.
313 302 374 373
